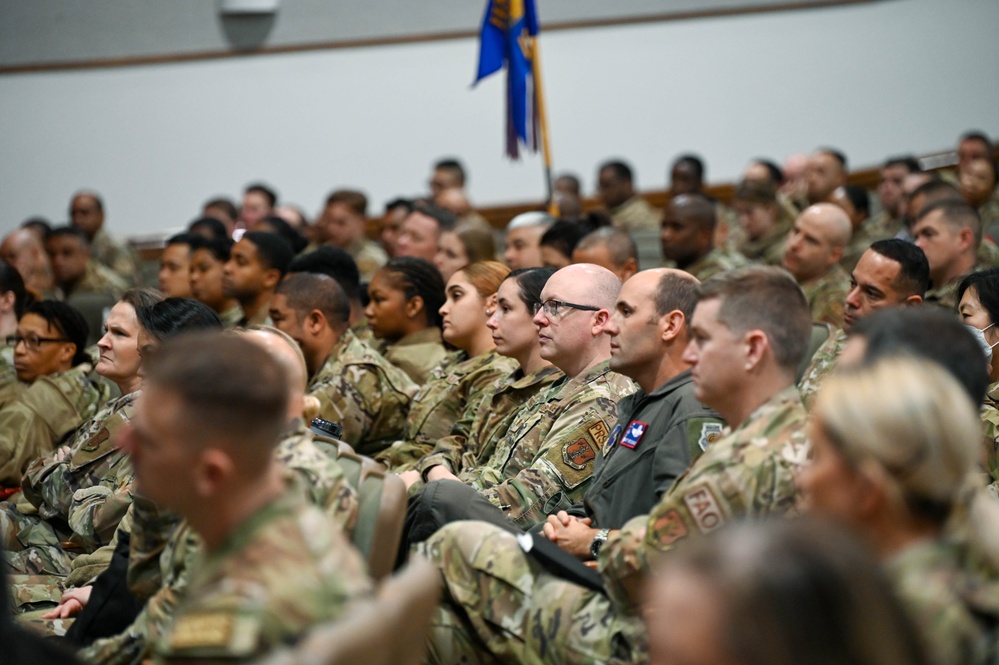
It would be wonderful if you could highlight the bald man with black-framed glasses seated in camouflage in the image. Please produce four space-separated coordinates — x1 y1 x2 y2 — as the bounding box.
401 263 634 555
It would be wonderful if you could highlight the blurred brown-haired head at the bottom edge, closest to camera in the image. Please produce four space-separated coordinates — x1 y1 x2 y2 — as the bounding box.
645 519 930 665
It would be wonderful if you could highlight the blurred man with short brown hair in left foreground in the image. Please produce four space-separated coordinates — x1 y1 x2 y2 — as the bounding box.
122 334 370 663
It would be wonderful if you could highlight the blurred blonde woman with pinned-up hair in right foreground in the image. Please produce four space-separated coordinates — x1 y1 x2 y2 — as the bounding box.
799 357 999 665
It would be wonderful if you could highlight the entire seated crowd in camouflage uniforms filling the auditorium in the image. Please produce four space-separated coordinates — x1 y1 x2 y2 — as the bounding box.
0 132 999 665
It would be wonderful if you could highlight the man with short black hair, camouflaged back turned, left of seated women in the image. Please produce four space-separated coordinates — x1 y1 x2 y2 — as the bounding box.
269 273 417 455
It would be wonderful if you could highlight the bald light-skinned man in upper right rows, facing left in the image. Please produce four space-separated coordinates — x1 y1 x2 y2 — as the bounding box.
782 203 852 328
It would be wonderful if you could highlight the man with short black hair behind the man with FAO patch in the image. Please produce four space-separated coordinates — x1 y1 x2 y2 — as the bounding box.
798 238 930 407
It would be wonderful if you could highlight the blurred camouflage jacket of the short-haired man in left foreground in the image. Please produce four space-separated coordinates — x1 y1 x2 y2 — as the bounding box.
154 491 371 663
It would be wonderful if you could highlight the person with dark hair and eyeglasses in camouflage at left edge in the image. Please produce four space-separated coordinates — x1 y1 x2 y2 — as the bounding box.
0 301 109 488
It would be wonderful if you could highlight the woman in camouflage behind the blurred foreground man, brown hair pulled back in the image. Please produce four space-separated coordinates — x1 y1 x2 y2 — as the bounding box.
0 289 160 584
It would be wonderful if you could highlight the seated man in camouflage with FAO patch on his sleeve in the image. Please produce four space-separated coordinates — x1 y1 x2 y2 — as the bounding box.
420 267 811 663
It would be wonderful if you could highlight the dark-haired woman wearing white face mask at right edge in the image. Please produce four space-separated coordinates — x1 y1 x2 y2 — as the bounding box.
957 268 999 492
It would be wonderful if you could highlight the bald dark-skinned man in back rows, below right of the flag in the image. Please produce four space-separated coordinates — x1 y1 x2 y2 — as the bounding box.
659 194 747 281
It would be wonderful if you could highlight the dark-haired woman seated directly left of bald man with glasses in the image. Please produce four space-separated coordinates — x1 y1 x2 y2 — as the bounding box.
403 268 562 485
